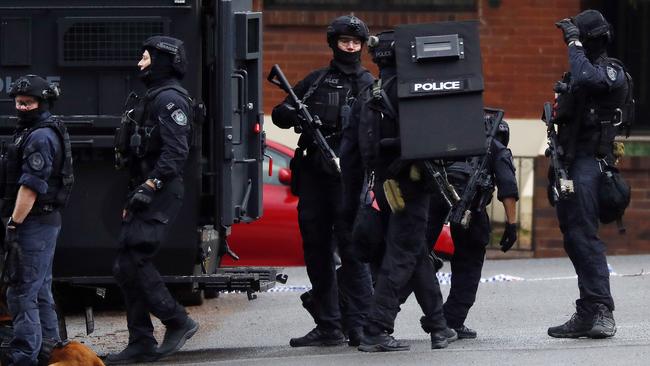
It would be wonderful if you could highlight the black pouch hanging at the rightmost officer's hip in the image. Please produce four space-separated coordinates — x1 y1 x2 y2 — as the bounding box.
598 165 630 231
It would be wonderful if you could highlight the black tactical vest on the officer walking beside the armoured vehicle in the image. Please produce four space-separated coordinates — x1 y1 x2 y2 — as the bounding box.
114 85 200 175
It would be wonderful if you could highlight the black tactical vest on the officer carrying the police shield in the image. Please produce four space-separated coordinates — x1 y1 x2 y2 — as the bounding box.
359 76 399 170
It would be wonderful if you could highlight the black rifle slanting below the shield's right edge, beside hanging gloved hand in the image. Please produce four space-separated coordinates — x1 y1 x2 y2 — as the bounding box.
449 108 503 229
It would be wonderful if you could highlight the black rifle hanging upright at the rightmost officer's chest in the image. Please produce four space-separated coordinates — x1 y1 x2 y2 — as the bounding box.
542 102 574 205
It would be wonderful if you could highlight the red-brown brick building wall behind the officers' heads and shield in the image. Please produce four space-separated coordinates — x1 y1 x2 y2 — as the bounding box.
254 0 580 118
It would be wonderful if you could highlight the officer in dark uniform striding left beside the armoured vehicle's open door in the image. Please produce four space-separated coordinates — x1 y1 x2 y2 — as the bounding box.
107 36 199 364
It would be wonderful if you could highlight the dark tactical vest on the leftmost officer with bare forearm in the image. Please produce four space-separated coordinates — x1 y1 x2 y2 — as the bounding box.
0 117 74 216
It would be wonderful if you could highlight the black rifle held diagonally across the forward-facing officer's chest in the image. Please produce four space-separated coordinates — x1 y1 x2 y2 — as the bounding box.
266 64 341 173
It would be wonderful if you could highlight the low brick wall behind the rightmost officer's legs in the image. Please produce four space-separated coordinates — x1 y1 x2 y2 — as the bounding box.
533 156 650 257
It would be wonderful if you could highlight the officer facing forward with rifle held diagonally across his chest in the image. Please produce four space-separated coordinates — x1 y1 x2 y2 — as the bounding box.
272 15 373 347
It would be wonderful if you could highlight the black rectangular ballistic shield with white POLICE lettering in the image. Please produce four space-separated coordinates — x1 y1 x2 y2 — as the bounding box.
395 21 485 159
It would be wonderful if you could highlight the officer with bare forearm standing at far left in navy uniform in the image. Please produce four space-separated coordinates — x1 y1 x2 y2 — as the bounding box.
2 75 73 365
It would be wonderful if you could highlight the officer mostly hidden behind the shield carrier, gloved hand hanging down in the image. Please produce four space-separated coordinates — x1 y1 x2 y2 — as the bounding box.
440 119 519 339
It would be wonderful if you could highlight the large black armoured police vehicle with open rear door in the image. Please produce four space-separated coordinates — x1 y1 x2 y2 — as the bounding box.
0 0 281 308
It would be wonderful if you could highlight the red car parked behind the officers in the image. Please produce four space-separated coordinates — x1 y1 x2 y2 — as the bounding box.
221 140 454 267
